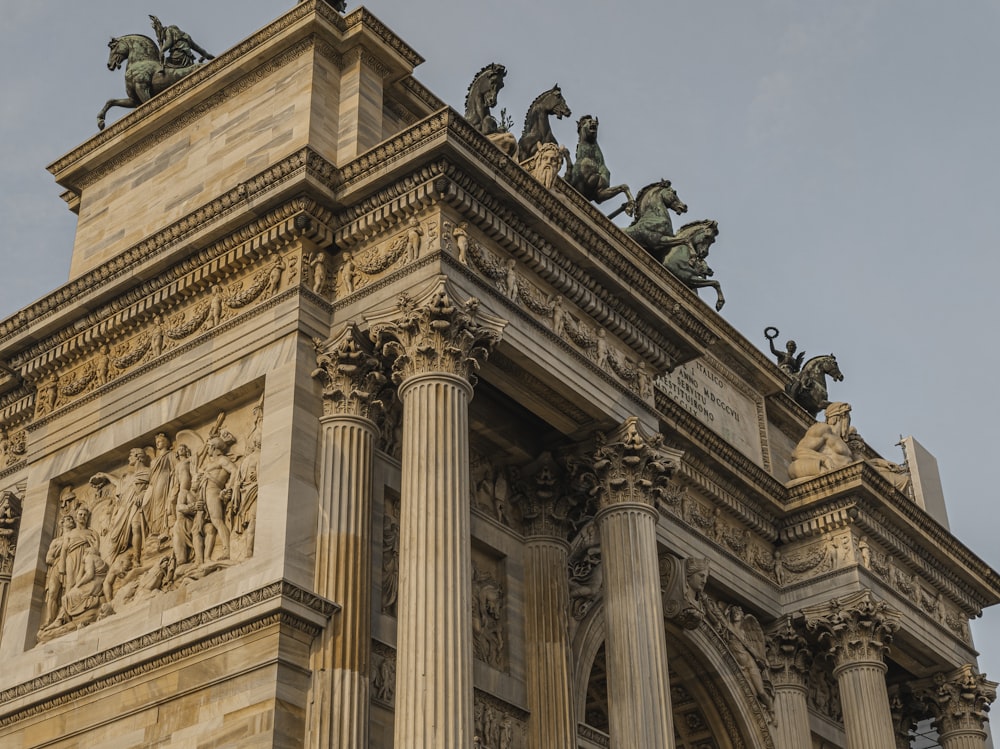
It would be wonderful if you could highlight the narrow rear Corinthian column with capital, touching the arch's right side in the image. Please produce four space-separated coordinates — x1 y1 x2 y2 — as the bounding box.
767 619 812 749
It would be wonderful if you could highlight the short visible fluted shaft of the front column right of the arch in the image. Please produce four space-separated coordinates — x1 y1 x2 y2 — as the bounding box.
833 661 896 749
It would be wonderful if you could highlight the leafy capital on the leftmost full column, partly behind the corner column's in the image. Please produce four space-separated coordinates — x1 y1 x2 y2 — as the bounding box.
312 324 386 420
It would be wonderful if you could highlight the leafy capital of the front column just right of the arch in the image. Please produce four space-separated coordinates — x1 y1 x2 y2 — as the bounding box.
802 590 901 668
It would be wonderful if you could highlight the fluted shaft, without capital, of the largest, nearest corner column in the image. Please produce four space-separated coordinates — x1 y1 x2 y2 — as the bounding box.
394 373 474 749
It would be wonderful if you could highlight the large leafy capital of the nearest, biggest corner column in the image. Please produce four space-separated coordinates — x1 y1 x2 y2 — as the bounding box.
366 276 507 385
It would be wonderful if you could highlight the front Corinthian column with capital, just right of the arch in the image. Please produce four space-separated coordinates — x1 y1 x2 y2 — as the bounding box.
803 590 900 749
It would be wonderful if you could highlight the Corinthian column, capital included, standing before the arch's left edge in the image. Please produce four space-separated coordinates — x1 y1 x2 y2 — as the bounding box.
593 417 681 749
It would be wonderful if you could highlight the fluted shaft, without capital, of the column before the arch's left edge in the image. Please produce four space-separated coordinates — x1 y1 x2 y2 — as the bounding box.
598 496 674 749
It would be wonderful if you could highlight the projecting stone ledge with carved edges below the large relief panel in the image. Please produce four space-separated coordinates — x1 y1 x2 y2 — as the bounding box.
0 580 339 726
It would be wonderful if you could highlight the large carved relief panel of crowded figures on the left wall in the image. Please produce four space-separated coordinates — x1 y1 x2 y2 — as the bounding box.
37 392 263 642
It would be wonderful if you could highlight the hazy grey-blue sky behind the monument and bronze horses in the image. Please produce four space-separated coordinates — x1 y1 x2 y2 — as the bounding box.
0 0 1000 720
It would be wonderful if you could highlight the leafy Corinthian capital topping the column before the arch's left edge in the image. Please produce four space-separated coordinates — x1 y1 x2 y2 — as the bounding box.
593 416 683 509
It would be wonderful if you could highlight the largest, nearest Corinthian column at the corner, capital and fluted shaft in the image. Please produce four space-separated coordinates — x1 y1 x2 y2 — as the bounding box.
367 277 506 749
